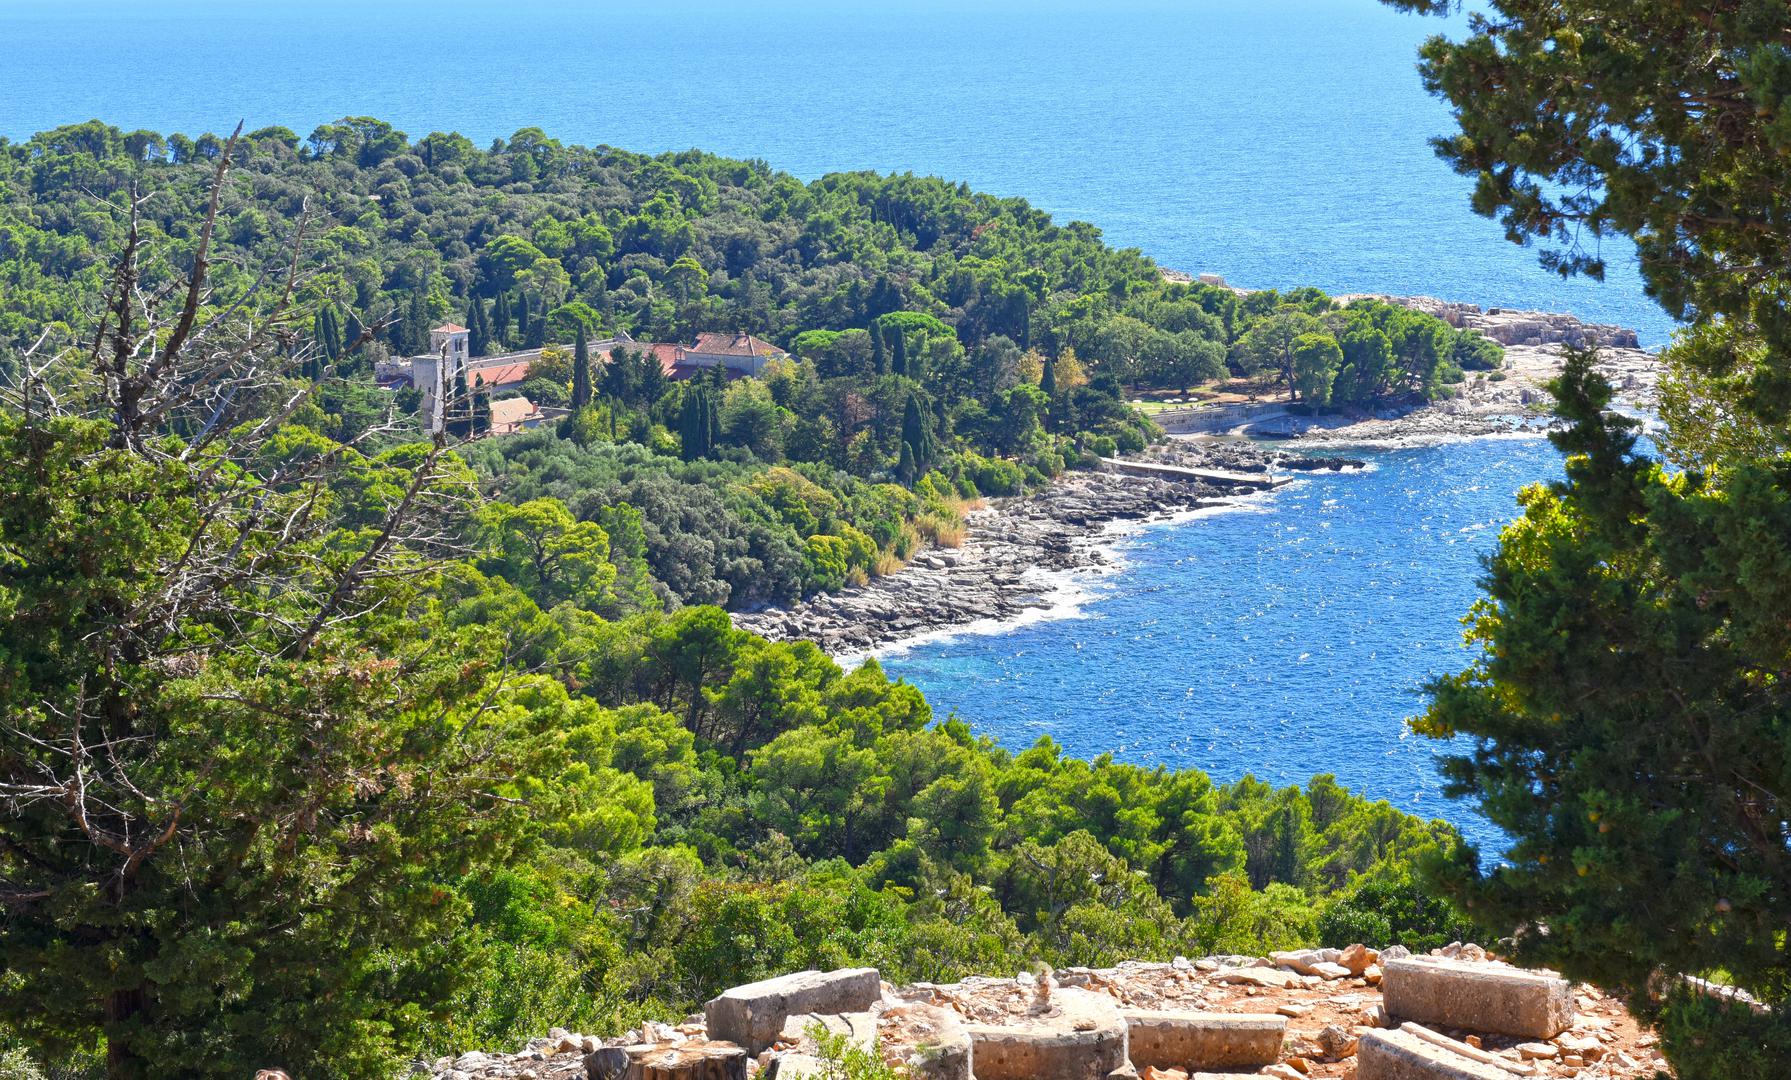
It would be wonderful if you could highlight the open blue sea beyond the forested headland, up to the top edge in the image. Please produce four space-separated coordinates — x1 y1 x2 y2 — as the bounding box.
0 0 1669 342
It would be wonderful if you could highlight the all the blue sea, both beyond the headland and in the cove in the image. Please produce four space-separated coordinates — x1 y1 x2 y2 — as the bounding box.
0 0 1673 840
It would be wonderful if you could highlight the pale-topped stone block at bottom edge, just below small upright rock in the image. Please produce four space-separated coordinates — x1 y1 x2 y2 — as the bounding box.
965 990 1127 1080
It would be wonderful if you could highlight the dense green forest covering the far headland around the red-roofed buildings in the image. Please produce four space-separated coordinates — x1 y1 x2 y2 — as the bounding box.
0 118 1499 607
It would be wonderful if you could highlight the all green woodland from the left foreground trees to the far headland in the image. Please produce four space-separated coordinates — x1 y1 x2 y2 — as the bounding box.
0 122 1476 1078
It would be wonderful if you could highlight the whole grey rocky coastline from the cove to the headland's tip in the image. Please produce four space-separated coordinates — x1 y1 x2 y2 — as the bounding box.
734 294 1660 663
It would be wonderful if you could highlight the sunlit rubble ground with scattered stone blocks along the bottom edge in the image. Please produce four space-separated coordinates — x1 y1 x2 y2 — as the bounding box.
426 944 1666 1080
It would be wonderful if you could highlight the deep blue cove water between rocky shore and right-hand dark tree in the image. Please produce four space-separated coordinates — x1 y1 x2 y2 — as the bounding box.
883 437 1560 851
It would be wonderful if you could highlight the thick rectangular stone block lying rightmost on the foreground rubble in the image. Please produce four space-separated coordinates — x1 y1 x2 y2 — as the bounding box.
1381 956 1572 1039
